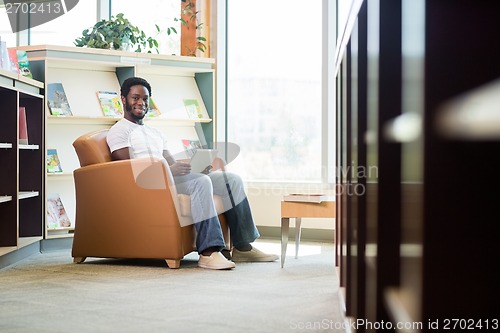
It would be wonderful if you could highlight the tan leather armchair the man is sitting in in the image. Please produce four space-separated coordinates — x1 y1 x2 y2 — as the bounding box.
72 130 230 268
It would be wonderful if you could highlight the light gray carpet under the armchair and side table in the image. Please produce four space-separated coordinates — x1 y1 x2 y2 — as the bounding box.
0 241 343 333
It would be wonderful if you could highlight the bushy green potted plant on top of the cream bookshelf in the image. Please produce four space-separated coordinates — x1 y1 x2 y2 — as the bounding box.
74 13 160 53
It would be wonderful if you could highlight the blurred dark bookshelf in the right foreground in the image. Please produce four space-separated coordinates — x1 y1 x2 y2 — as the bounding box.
336 0 500 333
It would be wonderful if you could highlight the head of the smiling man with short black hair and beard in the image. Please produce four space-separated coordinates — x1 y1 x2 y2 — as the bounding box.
120 77 151 124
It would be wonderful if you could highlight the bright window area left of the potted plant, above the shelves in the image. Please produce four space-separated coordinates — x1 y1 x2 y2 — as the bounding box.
30 0 97 46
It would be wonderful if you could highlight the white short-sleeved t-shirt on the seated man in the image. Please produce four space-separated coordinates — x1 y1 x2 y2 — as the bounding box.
106 118 167 158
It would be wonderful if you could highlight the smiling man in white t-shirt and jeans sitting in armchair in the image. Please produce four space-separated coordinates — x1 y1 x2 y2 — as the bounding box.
107 77 278 269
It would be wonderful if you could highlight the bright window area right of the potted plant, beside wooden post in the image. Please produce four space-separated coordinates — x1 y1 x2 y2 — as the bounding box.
111 0 181 55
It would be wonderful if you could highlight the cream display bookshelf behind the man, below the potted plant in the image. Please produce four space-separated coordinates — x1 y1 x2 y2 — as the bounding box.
17 45 216 239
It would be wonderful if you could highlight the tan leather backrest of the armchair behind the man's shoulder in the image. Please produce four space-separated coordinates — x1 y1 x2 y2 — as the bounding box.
73 129 112 167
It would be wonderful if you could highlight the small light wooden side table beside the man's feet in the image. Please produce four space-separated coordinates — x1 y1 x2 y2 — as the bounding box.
281 200 335 268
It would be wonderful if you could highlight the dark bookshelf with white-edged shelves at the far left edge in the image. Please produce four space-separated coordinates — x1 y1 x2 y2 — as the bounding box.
0 70 45 255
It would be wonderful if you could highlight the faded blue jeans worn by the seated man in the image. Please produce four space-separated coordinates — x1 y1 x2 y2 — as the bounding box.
174 171 260 253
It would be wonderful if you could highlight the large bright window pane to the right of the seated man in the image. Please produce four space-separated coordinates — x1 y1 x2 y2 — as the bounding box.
227 0 322 182
